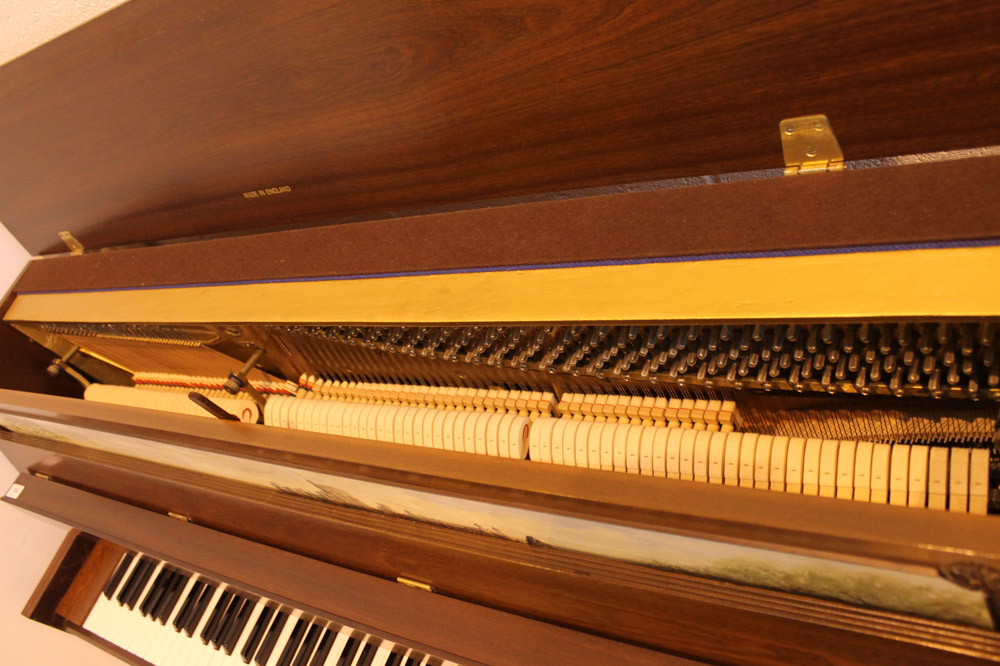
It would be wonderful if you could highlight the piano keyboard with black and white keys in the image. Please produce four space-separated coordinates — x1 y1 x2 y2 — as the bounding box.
83 552 454 666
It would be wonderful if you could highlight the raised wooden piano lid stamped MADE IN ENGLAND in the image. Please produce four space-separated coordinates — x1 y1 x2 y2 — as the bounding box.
0 0 1000 253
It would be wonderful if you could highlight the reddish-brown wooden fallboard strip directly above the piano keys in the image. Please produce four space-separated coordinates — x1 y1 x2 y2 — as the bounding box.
7 476 683 666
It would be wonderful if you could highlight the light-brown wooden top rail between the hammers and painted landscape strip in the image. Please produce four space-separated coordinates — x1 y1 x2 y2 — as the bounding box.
0 391 1000 568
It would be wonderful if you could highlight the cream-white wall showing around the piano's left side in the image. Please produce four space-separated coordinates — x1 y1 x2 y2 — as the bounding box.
0 0 131 666
